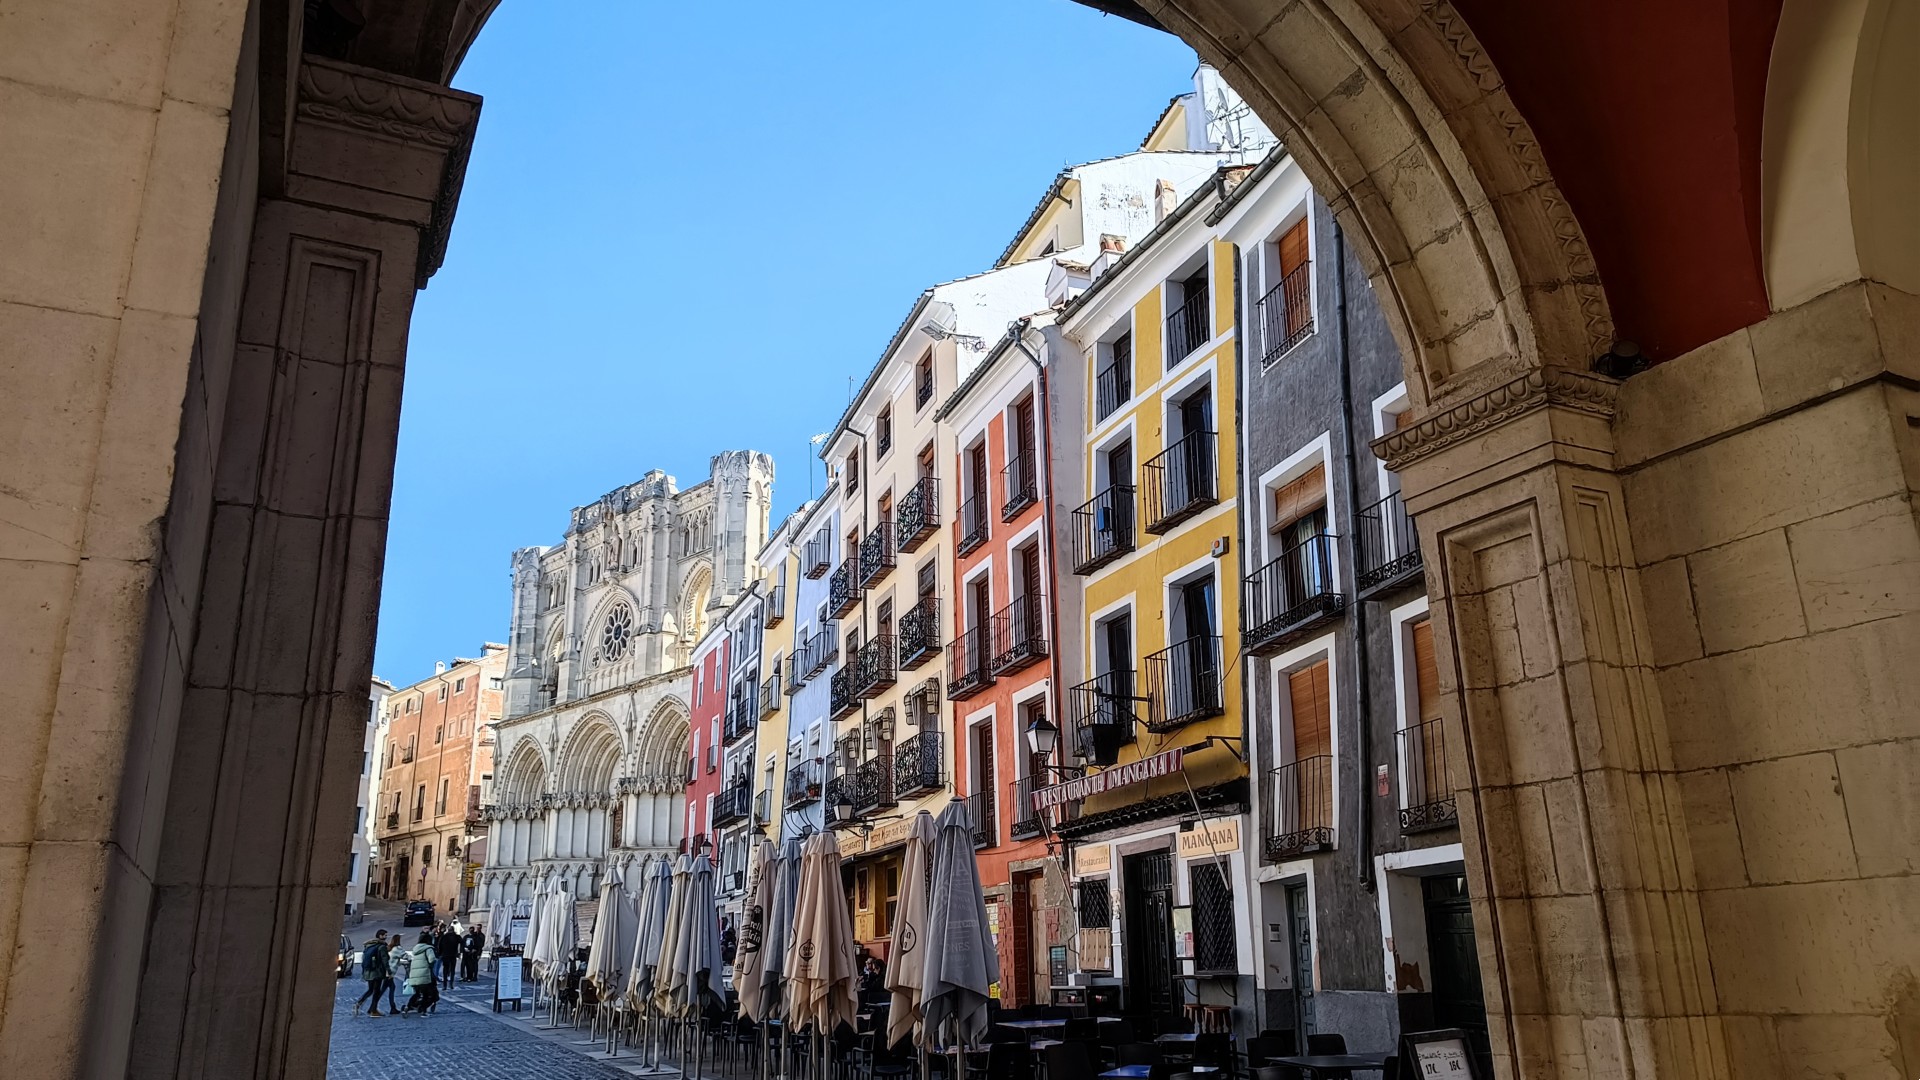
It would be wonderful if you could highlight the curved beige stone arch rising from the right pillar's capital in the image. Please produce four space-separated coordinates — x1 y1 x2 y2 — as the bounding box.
1140 0 1613 403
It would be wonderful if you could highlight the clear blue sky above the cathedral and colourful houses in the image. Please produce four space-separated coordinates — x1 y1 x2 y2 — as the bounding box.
374 0 1194 682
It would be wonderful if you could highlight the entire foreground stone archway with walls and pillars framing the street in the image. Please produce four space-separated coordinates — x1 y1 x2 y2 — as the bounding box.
0 0 1920 1080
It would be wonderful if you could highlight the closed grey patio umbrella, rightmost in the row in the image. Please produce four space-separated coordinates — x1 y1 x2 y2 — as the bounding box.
920 799 1000 1047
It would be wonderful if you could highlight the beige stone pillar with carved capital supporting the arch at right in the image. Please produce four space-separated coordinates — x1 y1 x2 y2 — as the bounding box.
1375 367 1728 1080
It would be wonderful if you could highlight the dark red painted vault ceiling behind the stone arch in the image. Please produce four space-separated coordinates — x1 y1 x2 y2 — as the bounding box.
1079 0 1782 359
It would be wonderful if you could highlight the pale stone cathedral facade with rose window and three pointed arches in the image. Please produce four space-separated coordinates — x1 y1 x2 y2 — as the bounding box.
476 450 774 907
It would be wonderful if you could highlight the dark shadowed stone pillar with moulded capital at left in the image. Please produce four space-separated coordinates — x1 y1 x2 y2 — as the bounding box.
118 60 480 1080
